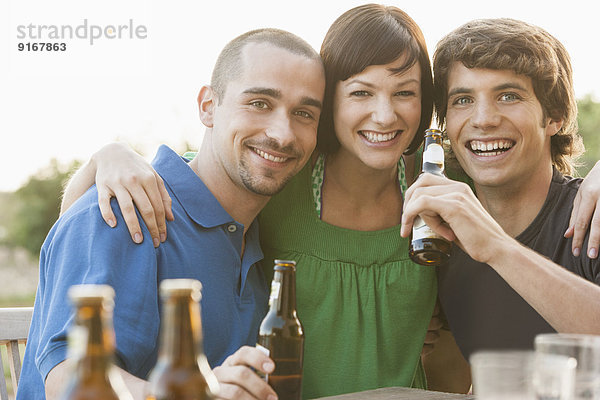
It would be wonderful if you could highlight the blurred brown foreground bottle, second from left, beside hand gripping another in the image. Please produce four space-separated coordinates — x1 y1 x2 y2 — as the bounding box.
146 279 218 400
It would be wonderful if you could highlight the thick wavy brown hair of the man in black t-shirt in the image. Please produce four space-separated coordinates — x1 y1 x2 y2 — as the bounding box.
433 18 584 175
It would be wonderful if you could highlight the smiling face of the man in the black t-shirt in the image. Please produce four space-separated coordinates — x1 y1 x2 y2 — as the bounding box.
446 62 562 191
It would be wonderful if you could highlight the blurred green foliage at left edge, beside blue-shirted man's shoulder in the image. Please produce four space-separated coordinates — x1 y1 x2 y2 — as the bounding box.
3 160 80 256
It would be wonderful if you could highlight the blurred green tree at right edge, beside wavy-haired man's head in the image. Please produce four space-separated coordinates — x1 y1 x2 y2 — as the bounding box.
577 96 600 176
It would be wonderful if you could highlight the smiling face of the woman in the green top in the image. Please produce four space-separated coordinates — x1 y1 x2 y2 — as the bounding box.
333 58 421 169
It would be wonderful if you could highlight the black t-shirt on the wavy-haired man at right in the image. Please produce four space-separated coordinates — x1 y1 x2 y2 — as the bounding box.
438 170 600 360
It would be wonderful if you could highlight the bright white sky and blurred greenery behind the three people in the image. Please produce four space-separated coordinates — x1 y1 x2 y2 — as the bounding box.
0 0 600 306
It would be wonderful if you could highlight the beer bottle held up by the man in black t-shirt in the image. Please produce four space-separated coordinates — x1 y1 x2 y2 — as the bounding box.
408 129 451 266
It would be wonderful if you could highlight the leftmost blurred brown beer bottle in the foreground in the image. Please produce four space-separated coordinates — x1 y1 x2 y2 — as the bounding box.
61 285 133 400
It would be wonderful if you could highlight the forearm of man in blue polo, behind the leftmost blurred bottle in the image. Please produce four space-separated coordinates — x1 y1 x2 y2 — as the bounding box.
46 360 147 400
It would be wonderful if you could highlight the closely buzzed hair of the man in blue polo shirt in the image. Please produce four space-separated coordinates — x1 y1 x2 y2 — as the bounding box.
210 28 321 102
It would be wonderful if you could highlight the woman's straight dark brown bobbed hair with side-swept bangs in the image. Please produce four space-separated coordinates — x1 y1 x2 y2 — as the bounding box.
317 4 433 153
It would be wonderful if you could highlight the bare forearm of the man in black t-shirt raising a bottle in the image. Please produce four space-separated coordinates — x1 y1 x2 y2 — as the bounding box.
489 239 600 334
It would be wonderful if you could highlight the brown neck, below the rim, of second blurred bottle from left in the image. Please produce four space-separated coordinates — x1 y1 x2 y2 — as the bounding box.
160 296 202 366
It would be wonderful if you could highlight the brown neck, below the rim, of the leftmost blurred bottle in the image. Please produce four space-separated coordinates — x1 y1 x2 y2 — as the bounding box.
70 304 115 377
